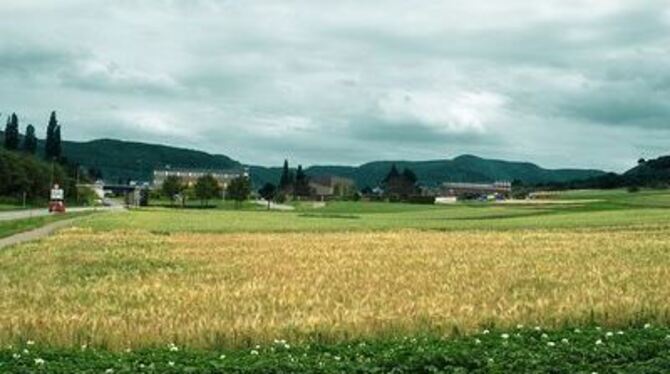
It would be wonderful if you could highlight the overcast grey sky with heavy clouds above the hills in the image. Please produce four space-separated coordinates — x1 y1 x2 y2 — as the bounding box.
0 0 670 171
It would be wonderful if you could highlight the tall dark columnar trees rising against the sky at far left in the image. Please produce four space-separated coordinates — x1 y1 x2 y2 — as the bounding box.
4 111 62 161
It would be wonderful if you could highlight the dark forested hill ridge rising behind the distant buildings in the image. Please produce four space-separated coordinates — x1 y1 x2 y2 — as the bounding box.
0 132 605 188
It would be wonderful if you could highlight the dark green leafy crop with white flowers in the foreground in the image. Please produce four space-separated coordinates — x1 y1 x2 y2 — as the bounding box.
0 325 670 374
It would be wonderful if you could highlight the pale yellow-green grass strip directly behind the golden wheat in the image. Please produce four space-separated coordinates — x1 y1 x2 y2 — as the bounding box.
86 203 670 233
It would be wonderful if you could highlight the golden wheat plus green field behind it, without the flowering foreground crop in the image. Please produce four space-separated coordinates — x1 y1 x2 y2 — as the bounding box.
0 191 670 367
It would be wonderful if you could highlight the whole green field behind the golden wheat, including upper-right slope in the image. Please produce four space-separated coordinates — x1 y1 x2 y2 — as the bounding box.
83 191 670 233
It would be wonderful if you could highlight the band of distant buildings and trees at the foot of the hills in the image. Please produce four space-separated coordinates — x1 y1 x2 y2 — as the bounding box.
90 163 512 205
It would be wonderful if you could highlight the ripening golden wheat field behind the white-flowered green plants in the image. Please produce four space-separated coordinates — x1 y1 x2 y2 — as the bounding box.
0 228 670 349
